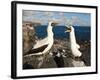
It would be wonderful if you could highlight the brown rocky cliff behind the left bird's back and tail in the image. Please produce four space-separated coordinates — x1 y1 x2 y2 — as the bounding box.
22 23 36 55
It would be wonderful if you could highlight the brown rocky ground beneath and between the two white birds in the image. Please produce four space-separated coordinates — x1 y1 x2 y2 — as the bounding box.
23 40 91 69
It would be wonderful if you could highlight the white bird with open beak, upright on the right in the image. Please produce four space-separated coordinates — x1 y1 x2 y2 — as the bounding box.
66 26 82 57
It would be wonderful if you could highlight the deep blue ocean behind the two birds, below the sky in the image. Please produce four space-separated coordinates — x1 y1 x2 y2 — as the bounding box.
35 25 91 41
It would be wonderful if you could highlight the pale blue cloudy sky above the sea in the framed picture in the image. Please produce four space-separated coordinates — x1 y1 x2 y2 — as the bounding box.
22 10 91 26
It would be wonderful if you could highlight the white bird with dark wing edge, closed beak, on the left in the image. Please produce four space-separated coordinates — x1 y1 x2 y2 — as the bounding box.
23 21 54 56
